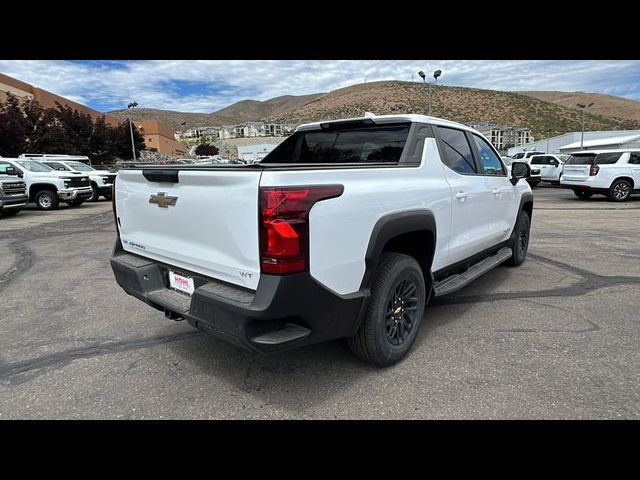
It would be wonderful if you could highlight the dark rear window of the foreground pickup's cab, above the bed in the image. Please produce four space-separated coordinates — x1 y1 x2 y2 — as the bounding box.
260 123 411 164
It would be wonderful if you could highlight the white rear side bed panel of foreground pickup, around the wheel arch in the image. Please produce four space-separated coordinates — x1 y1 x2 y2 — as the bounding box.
260 138 451 295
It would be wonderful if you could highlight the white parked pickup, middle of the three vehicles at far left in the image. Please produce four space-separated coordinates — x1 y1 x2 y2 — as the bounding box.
0 157 92 210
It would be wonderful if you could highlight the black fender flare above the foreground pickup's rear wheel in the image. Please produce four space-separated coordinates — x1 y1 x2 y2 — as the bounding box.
360 210 437 290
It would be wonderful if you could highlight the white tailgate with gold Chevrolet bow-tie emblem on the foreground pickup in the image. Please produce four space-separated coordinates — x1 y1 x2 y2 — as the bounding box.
115 167 261 290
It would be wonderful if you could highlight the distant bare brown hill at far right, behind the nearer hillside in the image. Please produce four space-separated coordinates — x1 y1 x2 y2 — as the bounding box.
518 92 640 121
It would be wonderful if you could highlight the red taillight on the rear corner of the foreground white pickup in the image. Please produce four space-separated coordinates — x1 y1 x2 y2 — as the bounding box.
260 185 344 275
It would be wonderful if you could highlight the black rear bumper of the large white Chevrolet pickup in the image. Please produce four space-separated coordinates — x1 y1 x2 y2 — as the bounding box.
111 240 368 353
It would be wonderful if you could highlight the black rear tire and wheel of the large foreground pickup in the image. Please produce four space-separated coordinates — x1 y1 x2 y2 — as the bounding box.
348 252 426 367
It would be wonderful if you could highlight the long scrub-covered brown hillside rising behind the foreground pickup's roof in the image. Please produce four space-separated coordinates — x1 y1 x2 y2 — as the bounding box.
110 81 640 138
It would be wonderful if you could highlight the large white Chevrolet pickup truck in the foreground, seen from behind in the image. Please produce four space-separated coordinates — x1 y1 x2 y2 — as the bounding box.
111 115 533 366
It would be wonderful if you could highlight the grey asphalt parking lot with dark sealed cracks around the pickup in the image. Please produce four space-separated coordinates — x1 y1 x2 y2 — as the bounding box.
0 187 640 419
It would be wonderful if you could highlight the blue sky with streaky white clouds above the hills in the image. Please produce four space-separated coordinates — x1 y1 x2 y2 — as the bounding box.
0 60 640 112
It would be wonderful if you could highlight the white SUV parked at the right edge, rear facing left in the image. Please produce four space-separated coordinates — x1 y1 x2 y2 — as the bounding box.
560 149 640 202
